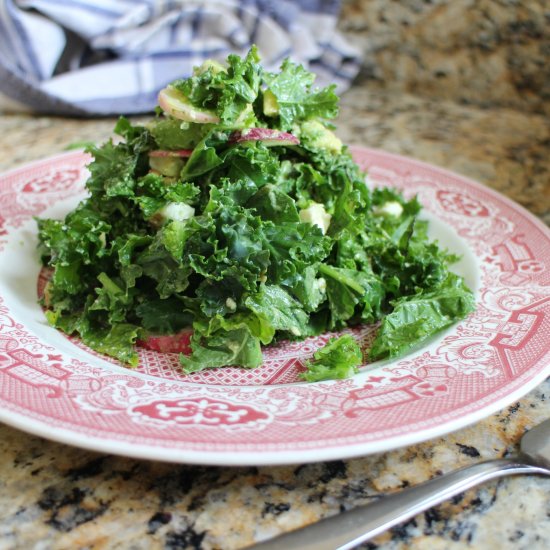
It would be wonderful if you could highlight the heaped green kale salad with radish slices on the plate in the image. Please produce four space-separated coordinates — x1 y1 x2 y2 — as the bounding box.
38 48 474 381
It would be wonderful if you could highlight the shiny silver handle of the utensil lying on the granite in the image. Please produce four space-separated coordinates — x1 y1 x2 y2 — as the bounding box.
249 459 548 550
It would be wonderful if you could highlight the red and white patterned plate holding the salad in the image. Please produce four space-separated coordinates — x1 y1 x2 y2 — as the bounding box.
0 148 550 465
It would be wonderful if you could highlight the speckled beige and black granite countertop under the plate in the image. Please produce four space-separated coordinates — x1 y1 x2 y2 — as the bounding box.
0 81 550 550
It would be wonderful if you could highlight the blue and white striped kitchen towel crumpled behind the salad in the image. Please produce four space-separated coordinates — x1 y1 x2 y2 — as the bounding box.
0 0 360 116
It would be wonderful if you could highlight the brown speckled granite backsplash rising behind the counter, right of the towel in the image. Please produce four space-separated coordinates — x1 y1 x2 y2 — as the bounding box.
340 0 550 114
